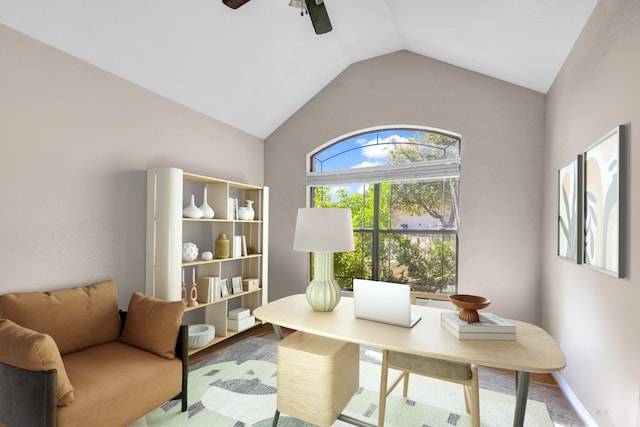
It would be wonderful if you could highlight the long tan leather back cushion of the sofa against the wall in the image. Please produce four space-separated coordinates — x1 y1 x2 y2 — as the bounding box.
0 280 120 355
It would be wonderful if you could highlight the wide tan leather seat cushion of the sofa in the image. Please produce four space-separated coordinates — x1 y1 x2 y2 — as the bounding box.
56 341 182 427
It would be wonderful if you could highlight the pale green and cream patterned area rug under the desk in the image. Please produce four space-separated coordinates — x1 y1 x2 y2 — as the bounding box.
130 337 553 427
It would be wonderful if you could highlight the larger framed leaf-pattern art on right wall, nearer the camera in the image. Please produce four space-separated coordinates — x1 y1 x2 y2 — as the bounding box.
582 125 624 277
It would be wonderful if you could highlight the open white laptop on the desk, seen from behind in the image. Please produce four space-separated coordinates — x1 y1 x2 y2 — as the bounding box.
353 279 421 328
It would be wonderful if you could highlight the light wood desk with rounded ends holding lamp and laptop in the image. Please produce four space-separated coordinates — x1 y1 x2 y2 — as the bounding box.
254 294 566 426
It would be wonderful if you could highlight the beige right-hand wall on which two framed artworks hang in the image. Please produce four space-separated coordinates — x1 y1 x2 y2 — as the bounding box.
542 0 640 427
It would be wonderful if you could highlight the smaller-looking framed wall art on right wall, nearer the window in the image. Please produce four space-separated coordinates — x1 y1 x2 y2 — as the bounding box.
558 155 582 263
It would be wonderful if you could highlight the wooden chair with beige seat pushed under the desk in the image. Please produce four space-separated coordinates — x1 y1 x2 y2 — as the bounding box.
378 350 480 427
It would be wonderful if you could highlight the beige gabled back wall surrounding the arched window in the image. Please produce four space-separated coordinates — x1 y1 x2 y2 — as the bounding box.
265 51 545 321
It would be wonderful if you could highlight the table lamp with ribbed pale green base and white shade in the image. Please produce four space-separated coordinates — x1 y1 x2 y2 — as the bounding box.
293 208 354 311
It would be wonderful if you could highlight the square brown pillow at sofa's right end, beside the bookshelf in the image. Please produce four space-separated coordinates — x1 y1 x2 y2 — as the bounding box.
120 292 186 359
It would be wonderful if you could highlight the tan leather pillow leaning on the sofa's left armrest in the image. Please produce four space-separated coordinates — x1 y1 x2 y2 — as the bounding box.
0 319 74 406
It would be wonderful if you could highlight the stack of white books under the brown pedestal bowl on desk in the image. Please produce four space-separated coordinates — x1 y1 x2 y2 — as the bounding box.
440 311 516 341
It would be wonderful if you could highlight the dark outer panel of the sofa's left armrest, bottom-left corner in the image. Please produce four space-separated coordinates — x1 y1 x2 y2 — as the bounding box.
0 362 57 427
